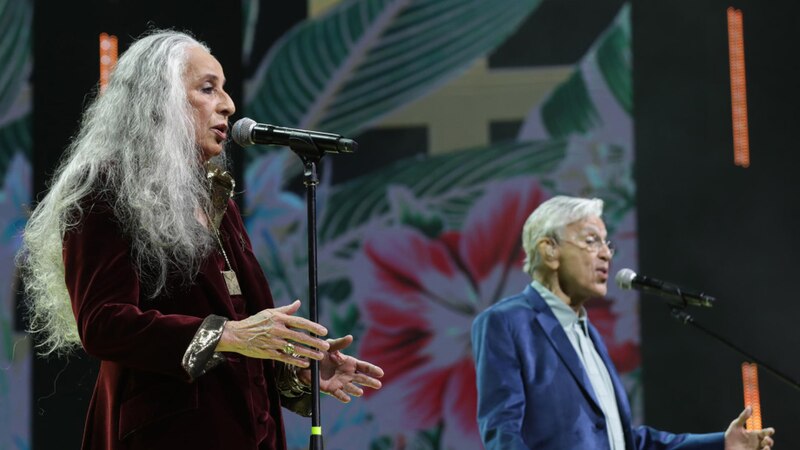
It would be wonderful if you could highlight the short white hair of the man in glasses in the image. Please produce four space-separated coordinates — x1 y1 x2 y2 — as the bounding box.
522 195 603 277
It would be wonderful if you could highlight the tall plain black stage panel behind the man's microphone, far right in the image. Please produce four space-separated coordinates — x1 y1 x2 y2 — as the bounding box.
633 0 800 448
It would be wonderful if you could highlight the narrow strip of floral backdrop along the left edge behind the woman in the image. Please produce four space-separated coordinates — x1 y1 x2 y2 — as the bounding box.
0 5 33 449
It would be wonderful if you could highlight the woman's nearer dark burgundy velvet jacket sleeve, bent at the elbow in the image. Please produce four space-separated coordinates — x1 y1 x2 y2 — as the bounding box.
62 203 203 381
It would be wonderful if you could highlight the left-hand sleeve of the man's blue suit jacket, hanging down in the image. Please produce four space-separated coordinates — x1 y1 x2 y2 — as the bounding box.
472 310 528 450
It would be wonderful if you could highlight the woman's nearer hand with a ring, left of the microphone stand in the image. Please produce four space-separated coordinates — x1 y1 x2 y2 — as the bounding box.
216 300 331 367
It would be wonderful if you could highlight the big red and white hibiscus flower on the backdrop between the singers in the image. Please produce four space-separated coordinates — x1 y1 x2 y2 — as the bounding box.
354 179 544 449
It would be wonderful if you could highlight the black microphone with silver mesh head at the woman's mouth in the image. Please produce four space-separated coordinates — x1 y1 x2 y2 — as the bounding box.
231 117 358 158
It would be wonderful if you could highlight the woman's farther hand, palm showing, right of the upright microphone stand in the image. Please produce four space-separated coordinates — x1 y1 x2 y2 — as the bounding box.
298 334 383 403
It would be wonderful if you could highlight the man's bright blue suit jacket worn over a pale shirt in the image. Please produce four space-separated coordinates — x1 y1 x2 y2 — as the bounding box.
472 285 724 450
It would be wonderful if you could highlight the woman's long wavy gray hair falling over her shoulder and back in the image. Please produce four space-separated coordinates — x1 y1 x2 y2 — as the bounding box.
18 31 219 354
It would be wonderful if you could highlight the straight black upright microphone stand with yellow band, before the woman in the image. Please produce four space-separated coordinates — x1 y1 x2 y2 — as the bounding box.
298 153 324 450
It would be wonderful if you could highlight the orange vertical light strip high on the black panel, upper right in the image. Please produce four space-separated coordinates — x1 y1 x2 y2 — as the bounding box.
728 7 750 167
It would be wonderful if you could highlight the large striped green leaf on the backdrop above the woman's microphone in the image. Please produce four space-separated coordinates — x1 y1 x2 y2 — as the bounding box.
246 0 540 134
